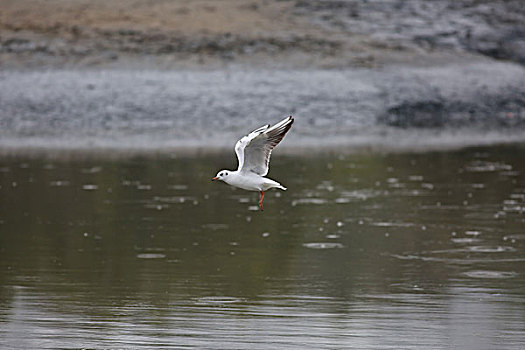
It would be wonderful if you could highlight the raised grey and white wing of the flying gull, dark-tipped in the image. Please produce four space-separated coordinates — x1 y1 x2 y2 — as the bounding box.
235 117 294 176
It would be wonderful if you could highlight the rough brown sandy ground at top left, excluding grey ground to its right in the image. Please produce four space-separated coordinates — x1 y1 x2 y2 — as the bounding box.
0 0 345 68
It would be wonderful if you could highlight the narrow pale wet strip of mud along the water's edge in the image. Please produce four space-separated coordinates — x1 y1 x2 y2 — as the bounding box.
0 129 525 159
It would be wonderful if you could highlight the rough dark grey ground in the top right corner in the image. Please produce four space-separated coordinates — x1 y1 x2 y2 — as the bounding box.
295 0 525 64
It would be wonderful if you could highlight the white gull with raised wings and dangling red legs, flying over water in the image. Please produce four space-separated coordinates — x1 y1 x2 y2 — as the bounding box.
212 116 293 210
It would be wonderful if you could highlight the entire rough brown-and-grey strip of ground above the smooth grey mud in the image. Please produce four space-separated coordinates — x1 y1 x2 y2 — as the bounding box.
0 0 525 69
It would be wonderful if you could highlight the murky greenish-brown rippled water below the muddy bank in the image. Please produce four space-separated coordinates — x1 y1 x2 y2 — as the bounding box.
0 146 525 349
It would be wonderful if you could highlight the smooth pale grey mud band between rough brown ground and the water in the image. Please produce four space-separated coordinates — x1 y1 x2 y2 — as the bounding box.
0 61 525 152
